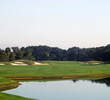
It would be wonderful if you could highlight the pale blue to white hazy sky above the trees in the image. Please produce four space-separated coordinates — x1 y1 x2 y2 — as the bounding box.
0 0 110 49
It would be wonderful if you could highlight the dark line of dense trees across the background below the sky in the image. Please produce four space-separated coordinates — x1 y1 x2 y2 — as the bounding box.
0 45 110 62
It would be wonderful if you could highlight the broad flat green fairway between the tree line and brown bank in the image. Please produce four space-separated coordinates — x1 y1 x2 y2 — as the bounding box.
0 61 110 77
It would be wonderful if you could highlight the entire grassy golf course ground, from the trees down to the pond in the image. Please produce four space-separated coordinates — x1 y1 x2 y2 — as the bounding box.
0 60 110 100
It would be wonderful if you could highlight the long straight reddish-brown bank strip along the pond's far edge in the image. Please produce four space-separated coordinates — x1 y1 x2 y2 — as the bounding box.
7 74 110 80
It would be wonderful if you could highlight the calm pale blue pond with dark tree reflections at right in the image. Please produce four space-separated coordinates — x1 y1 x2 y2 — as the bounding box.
4 78 110 100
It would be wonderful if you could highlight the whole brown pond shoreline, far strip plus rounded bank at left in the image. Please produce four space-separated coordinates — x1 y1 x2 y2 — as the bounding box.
0 74 110 91
